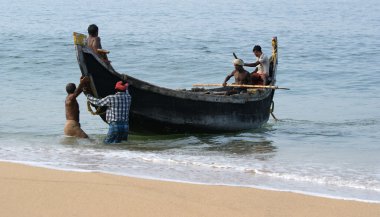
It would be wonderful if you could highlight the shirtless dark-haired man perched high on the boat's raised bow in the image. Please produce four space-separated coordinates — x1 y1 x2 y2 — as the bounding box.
86 24 111 64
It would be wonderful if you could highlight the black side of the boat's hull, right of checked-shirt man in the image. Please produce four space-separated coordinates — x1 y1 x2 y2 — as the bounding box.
129 87 274 133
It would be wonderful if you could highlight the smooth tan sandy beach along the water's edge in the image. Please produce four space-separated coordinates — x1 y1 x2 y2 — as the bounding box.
0 162 380 217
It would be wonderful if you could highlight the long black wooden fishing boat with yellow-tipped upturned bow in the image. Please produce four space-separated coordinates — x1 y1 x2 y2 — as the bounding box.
74 33 277 133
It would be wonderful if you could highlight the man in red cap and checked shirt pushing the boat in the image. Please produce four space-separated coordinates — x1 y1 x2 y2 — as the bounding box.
85 81 131 144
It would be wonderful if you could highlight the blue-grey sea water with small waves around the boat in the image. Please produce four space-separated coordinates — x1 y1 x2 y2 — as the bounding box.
0 0 380 202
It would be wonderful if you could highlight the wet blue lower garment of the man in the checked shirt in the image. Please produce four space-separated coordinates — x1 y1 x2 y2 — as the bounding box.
104 121 129 144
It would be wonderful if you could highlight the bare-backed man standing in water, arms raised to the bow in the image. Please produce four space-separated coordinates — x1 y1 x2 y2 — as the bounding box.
64 78 88 138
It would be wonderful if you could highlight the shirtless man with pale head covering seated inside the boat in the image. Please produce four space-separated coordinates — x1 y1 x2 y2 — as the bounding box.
223 59 251 95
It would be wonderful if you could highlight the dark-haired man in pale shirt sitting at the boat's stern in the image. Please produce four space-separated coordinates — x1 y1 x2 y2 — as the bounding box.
244 45 269 85
